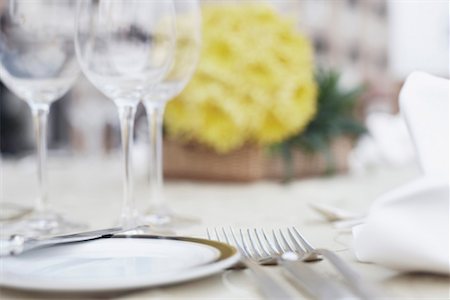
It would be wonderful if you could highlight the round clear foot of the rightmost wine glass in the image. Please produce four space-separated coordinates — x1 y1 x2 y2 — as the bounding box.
141 210 201 229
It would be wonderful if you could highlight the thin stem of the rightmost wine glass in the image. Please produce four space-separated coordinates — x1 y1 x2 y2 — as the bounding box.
145 102 167 213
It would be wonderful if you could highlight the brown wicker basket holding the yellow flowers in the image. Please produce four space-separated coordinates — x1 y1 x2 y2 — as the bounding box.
164 138 352 181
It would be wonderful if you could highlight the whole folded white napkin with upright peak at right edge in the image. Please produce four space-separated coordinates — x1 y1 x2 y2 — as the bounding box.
353 72 450 274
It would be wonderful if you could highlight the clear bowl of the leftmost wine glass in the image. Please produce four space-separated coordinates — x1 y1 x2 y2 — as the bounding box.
0 0 79 106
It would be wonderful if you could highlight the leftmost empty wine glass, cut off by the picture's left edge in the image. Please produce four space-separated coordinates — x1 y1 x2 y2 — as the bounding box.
0 0 79 235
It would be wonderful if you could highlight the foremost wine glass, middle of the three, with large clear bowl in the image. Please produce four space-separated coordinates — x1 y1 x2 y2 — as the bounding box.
75 0 175 228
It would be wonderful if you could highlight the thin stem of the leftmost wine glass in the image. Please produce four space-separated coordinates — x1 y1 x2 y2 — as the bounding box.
31 105 49 212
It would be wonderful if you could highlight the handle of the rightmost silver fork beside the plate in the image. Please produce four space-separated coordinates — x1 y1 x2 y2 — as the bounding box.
316 249 383 300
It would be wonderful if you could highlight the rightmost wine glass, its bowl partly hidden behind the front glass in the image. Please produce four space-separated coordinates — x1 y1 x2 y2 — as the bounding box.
143 0 201 227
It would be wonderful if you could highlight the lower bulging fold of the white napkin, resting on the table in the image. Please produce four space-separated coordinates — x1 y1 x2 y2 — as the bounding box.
353 178 450 274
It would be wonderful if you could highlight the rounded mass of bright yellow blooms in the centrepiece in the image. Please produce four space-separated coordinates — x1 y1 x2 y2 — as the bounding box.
165 4 317 153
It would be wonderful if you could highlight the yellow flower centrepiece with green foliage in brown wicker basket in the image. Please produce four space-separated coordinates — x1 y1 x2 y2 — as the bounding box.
160 1 363 181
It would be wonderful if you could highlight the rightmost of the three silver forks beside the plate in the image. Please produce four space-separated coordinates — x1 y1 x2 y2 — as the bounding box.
287 227 382 300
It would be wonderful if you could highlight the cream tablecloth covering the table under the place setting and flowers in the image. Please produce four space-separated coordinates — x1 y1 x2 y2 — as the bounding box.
0 157 450 299
